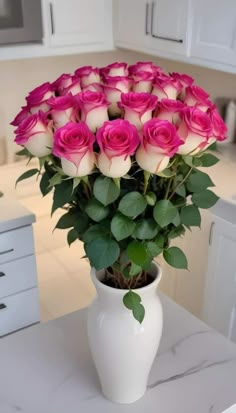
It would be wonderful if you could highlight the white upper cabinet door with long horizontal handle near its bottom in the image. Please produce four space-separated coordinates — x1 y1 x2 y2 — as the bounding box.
149 0 189 54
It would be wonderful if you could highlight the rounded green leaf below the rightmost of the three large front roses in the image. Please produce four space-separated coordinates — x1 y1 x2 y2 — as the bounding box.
153 199 178 228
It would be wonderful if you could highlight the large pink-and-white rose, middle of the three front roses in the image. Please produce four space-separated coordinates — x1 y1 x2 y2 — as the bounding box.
97 119 140 178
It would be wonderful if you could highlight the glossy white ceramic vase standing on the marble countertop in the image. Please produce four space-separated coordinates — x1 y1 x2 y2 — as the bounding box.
88 263 162 403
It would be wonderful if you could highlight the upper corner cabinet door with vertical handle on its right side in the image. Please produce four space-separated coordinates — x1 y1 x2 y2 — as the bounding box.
113 0 148 50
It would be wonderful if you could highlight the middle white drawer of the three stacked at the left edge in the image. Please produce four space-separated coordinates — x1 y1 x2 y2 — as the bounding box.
0 255 37 297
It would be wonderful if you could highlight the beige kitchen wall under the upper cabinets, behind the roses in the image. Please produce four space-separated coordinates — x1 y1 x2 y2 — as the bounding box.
0 50 236 164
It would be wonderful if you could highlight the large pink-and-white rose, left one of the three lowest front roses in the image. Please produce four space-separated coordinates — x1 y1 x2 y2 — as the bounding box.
52 122 95 177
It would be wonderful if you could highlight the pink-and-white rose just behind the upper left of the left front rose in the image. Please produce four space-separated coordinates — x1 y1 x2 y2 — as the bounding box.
47 95 79 129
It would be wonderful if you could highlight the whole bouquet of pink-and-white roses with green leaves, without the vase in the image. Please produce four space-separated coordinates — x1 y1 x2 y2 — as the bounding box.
12 62 226 322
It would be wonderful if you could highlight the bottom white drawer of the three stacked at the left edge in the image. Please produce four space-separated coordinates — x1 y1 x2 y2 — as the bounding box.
0 288 40 336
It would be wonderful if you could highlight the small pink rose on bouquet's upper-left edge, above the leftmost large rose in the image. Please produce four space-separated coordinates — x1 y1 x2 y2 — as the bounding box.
26 82 54 113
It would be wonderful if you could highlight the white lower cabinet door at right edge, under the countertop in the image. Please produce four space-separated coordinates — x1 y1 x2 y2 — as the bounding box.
203 216 236 341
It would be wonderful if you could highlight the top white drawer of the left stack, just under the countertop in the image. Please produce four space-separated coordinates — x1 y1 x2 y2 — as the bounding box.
0 225 34 264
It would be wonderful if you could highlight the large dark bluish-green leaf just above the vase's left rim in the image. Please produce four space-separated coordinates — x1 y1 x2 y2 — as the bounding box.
85 237 120 270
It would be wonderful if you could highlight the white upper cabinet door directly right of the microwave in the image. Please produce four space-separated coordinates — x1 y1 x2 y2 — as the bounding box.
48 0 107 46
